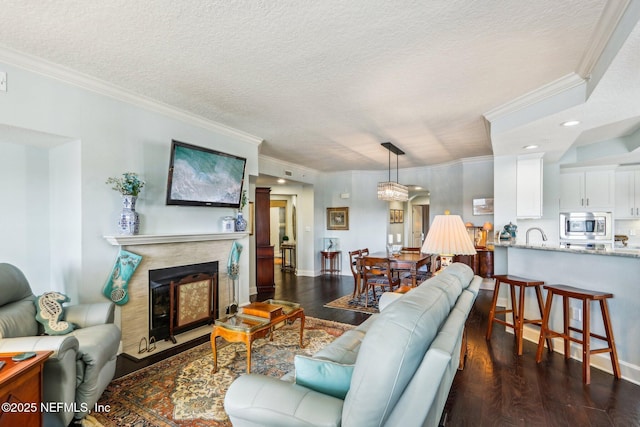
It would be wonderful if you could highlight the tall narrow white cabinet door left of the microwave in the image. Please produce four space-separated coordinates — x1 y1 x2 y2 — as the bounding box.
516 154 543 218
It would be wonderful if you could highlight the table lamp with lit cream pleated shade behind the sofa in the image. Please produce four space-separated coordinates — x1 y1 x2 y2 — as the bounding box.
422 211 476 268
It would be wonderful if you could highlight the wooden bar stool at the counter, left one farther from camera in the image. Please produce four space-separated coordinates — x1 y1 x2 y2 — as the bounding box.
486 274 553 356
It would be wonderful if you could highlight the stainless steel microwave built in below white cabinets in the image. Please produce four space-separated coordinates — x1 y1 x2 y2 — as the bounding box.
560 212 613 240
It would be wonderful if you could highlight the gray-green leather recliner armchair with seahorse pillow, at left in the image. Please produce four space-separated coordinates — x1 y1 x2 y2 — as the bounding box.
0 263 121 427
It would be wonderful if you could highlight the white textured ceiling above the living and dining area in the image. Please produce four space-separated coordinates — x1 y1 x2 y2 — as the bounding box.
0 0 637 171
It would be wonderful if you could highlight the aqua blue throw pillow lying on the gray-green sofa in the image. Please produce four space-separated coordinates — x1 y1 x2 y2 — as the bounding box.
294 355 353 399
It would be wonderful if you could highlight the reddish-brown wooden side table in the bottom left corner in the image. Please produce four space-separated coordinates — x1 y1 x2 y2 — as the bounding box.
0 351 53 426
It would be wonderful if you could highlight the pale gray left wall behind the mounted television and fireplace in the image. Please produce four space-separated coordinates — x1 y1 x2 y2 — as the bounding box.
0 63 259 302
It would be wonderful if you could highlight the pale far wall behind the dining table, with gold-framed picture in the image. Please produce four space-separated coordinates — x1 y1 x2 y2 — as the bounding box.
314 157 493 275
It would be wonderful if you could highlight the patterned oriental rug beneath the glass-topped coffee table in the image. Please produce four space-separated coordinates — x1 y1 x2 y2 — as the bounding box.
91 317 354 427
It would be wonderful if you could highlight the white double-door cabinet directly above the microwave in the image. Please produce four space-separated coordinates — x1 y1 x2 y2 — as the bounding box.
560 169 615 211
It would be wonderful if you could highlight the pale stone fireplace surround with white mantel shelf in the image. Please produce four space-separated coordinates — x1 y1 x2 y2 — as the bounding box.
105 233 245 357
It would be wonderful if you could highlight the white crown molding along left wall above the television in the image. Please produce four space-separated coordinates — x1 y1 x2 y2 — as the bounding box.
0 47 263 146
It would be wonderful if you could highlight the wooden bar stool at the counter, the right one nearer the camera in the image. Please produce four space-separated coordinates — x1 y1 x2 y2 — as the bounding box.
536 285 621 384
